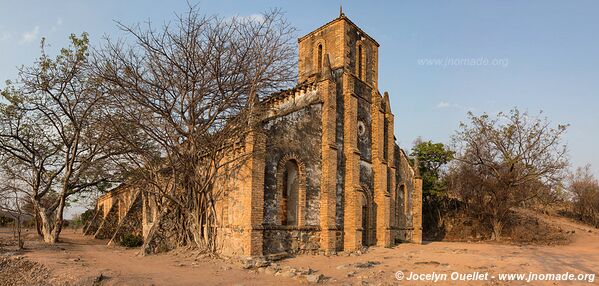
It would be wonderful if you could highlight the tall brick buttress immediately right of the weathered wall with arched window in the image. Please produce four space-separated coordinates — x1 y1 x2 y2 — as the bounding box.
318 79 337 253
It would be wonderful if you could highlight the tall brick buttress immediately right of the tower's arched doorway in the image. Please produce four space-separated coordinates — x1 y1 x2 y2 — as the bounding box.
370 90 391 247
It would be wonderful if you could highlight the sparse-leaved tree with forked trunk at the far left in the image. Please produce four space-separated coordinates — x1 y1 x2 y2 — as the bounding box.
0 33 132 243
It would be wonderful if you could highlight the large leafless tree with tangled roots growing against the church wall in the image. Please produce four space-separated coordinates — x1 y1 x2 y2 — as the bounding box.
95 7 296 251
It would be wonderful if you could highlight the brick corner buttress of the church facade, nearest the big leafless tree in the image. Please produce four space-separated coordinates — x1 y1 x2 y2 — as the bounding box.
240 130 266 256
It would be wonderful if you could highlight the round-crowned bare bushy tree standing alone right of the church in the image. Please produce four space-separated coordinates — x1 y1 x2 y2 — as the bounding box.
450 109 568 240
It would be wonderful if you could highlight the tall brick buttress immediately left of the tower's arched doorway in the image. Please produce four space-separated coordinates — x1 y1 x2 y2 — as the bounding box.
343 73 363 251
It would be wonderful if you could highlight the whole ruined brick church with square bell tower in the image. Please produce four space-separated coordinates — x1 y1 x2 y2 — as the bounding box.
85 13 422 256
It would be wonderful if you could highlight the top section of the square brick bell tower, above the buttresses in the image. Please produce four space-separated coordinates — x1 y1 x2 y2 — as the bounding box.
298 10 379 89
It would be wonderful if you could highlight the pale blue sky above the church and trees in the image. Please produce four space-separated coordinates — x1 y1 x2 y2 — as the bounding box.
0 0 599 212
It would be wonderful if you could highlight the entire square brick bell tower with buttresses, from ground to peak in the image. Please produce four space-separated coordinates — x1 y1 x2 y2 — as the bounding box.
298 11 395 251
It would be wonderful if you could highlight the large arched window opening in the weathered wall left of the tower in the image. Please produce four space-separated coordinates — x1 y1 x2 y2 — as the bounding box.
281 160 299 225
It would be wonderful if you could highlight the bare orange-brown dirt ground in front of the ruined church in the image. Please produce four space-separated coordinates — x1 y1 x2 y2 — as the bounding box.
0 211 599 285
